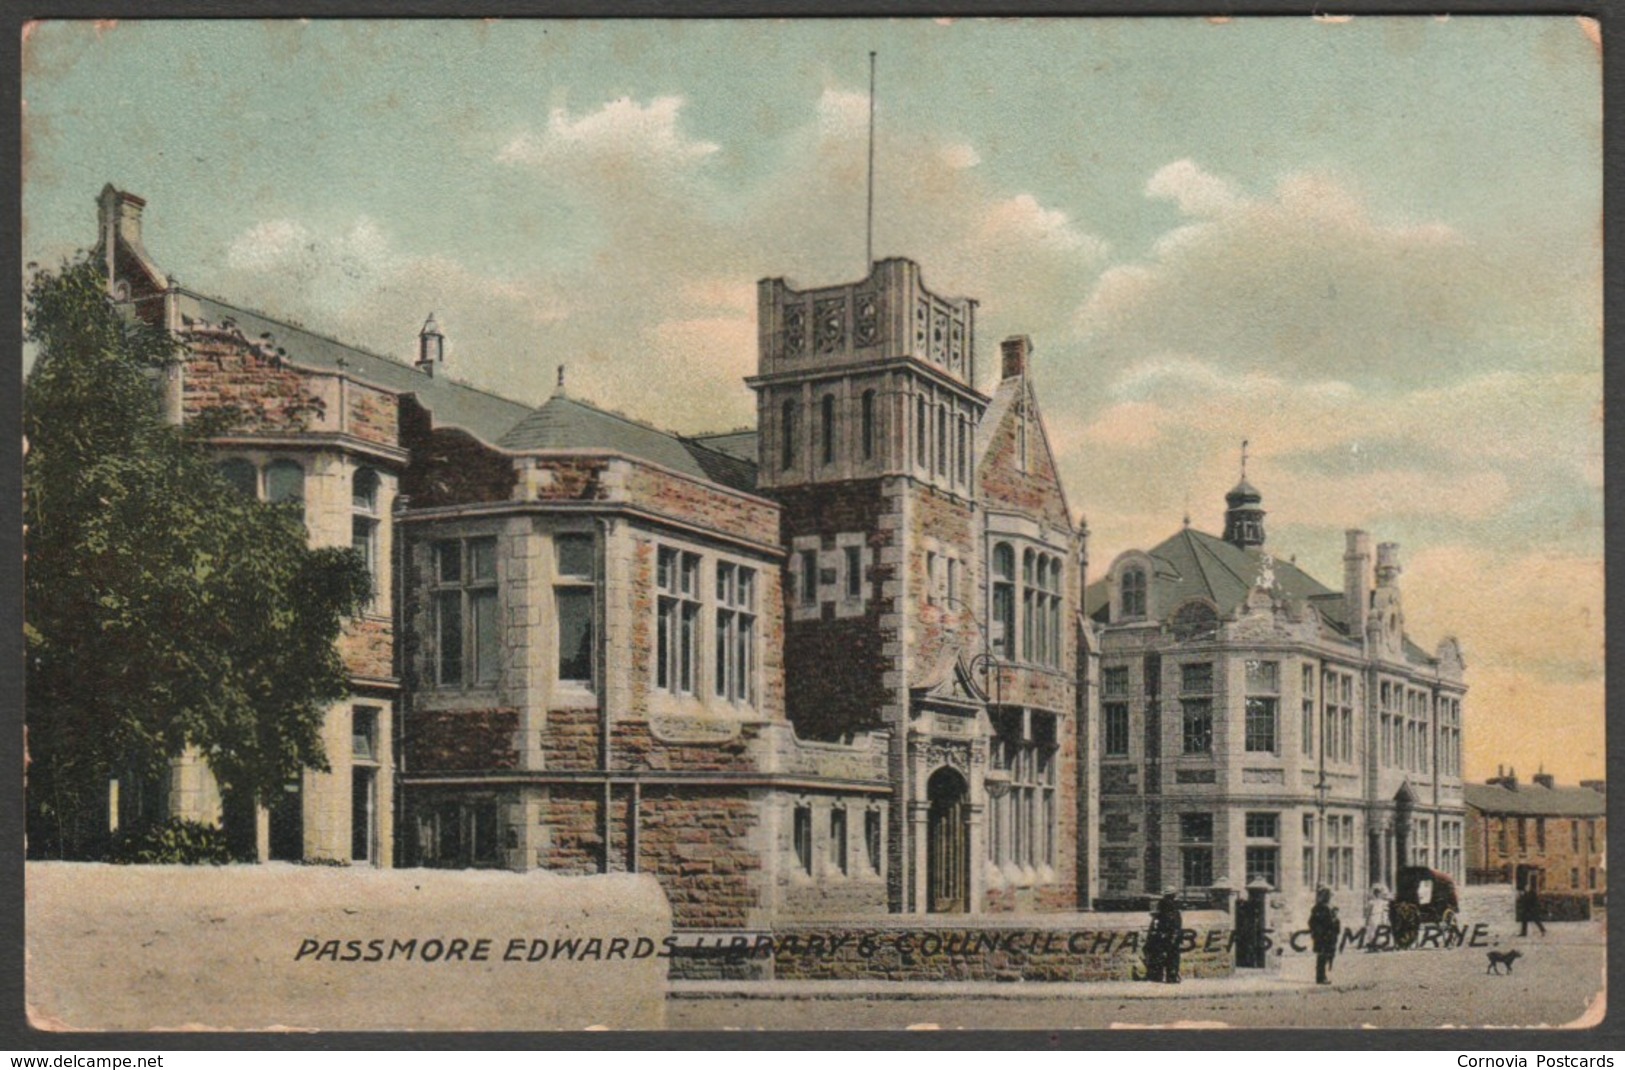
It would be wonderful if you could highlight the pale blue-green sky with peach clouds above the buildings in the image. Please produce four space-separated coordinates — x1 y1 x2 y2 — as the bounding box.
24 18 1602 776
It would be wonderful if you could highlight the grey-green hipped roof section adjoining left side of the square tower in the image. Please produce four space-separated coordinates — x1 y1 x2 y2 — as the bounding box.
496 394 756 491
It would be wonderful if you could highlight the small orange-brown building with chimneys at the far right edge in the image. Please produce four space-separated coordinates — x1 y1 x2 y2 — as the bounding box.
1464 769 1609 893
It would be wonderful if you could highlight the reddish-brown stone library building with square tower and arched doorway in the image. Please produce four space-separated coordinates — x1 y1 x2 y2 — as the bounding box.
79 187 1094 930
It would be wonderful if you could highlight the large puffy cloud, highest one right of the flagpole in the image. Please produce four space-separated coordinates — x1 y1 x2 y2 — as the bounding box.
1076 159 1601 389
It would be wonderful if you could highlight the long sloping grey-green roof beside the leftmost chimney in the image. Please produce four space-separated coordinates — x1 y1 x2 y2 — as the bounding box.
180 291 531 442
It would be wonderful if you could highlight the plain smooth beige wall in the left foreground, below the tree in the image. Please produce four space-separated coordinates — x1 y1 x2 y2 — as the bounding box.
24 862 671 1031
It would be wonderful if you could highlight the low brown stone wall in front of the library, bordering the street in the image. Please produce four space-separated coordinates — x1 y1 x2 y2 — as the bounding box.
671 911 1235 981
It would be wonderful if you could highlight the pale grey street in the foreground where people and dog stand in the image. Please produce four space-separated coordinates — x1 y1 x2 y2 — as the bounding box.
666 922 1606 1029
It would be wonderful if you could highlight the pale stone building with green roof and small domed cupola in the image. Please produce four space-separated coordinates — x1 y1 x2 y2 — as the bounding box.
1087 473 1466 903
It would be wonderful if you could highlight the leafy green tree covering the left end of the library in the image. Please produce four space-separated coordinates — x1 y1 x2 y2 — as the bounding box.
23 257 369 857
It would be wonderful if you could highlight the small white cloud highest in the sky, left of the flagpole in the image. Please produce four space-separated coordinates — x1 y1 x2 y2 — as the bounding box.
497 96 718 169
